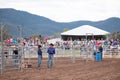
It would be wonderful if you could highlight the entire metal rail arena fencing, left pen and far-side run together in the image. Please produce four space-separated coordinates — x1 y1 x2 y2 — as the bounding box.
0 46 120 72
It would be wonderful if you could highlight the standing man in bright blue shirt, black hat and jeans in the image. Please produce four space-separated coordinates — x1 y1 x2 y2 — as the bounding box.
47 43 55 68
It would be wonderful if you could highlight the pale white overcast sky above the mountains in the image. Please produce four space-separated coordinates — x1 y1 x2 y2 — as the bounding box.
0 0 120 22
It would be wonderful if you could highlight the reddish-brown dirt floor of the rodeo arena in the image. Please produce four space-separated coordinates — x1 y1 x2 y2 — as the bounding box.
0 58 120 80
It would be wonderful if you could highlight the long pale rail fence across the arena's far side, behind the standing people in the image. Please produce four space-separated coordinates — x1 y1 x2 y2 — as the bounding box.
24 46 120 63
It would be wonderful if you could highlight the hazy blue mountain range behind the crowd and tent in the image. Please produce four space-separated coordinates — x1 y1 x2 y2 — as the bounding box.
0 8 120 35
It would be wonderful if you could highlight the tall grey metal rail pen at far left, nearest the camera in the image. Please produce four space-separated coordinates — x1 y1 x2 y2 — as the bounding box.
0 46 24 73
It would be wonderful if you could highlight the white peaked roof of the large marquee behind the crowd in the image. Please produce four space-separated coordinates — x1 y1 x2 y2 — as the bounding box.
61 25 110 38
